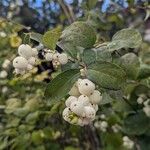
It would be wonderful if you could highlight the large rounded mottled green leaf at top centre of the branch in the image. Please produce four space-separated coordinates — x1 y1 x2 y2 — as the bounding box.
57 22 96 56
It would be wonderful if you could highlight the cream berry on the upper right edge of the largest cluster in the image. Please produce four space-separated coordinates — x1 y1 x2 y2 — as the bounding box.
89 90 102 104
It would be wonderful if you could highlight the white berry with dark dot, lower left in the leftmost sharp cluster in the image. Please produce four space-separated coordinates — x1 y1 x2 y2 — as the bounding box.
13 56 28 69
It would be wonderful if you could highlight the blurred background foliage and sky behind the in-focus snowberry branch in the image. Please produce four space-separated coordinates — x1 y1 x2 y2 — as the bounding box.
0 0 150 150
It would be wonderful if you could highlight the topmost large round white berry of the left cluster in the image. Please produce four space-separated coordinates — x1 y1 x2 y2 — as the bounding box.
18 44 32 59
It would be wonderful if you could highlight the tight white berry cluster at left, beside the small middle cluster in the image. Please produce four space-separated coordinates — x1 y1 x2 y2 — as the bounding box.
13 44 38 74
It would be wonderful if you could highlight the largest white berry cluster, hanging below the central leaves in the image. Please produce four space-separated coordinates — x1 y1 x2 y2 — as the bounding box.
63 79 102 126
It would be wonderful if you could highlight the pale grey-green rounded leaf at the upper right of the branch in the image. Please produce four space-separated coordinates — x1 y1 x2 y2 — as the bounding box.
108 28 142 51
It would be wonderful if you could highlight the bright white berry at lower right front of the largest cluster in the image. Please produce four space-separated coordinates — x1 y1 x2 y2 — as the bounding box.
84 106 96 120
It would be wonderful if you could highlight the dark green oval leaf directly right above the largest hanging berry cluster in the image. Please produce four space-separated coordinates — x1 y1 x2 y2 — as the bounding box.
87 62 126 90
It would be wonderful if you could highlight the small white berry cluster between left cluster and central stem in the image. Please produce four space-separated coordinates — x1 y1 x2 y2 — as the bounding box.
44 50 68 68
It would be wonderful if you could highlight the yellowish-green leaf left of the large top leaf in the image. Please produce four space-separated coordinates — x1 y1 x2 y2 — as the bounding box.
42 28 61 50
